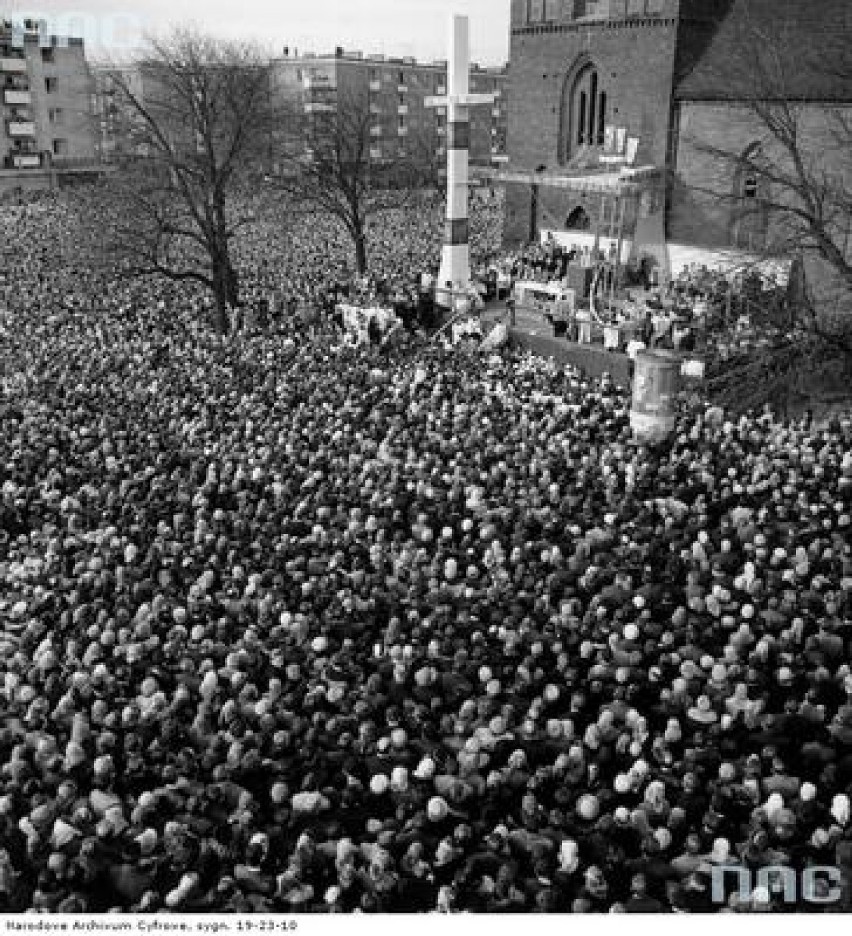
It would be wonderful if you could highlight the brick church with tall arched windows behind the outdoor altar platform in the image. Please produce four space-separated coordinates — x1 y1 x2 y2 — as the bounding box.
501 0 852 275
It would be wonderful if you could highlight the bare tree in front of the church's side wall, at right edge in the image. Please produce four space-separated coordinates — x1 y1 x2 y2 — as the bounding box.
685 11 852 410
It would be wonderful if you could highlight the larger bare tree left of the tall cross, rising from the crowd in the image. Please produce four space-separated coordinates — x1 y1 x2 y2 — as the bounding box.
85 30 275 331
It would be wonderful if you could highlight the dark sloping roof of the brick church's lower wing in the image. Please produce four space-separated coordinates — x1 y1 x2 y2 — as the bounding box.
675 0 852 103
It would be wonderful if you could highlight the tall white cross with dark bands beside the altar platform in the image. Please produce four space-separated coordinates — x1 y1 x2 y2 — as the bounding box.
425 14 494 308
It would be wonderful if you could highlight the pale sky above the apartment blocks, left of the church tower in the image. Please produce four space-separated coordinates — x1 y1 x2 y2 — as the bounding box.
0 0 510 65
